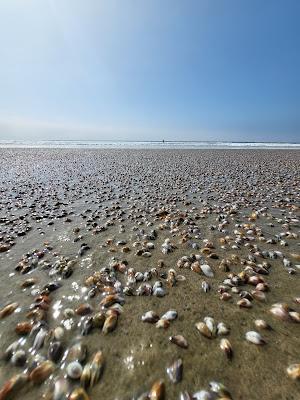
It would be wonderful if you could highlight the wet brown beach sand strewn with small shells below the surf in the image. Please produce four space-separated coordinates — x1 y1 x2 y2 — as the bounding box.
0 149 300 400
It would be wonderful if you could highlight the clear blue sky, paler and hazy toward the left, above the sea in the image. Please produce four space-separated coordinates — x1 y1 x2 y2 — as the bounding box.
0 0 300 142
